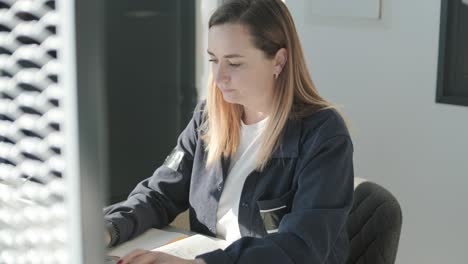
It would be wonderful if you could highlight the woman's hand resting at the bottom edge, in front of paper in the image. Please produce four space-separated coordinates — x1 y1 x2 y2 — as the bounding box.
118 249 205 264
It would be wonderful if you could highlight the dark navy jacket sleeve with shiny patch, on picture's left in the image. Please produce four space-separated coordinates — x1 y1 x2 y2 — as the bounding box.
104 100 203 246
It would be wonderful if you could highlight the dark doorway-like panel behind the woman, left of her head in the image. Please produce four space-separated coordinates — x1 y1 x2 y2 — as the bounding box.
105 0 197 203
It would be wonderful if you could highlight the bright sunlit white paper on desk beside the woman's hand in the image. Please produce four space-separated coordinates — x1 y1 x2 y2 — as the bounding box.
152 235 229 259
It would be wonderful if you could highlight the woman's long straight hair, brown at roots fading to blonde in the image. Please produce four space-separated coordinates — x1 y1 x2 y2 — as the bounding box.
202 0 348 170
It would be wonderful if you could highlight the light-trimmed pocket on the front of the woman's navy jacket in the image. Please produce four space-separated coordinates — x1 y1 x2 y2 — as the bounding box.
257 191 294 234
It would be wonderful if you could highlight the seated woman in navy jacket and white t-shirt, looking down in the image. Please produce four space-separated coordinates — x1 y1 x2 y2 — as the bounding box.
105 0 353 264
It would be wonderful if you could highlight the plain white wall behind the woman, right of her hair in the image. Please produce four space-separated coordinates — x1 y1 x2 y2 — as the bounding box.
286 0 468 264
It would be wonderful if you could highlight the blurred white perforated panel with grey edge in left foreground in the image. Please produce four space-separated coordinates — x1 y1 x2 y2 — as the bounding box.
0 0 107 264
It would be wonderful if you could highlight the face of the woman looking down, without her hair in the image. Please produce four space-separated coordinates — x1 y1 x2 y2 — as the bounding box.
208 24 275 111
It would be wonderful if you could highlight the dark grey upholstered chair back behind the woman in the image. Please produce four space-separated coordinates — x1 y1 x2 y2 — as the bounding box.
346 178 402 264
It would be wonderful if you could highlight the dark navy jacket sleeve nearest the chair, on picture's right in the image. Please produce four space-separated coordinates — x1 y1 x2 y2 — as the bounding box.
197 135 354 264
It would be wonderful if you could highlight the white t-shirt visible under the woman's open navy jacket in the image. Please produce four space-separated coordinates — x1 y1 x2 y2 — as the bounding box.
216 118 268 242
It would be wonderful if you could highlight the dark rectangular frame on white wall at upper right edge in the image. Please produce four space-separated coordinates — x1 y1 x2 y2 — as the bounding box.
436 0 468 106
